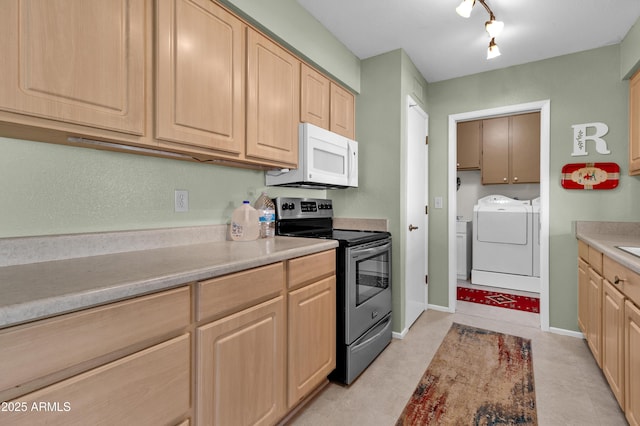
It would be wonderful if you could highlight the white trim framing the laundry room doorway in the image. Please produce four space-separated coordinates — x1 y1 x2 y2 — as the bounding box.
447 99 551 331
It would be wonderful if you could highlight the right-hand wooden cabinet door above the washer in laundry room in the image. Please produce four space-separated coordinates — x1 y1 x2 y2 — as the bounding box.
509 112 540 183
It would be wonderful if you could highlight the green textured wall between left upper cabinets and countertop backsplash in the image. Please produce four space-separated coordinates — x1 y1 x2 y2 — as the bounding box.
0 137 325 238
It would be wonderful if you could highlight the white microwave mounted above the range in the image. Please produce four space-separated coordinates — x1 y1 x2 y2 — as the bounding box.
265 123 358 189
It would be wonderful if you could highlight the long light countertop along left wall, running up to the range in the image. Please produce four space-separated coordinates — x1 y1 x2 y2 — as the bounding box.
0 237 338 328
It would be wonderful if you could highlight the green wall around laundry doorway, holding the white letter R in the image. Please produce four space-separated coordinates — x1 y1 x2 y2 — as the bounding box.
428 45 640 331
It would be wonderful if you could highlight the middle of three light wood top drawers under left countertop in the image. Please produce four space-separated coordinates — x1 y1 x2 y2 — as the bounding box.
196 262 284 321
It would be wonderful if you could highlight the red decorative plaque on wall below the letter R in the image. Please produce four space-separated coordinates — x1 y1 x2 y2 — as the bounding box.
561 163 620 189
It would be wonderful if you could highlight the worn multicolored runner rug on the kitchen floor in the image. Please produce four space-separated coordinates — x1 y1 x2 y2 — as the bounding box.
396 323 537 426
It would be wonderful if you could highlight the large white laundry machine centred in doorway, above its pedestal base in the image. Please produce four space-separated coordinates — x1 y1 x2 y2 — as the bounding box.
471 195 533 283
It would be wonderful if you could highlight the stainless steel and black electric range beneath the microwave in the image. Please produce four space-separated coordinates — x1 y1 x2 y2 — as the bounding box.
274 197 391 384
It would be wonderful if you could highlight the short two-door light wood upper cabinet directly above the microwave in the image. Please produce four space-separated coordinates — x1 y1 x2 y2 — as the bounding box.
300 63 355 139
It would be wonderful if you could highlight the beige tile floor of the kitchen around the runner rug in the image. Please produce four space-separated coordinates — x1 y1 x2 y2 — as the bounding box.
290 302 627 426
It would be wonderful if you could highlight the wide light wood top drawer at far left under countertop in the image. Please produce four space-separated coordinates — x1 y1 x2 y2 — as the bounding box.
0 287 191 400
